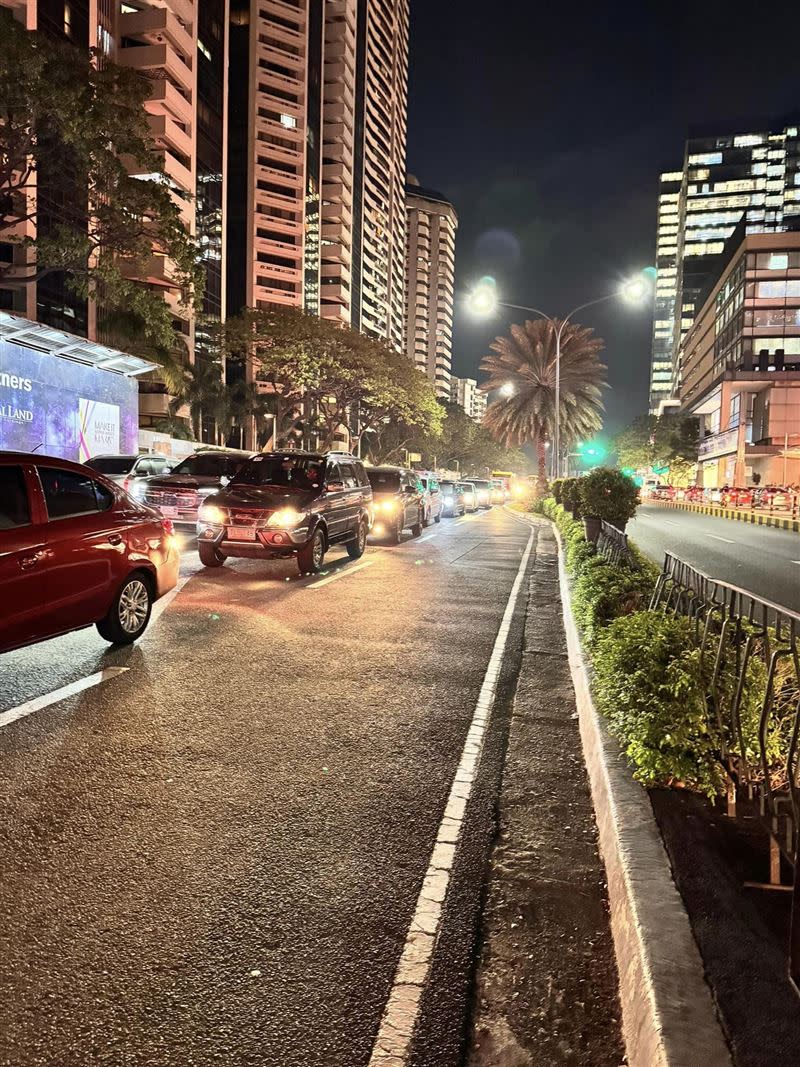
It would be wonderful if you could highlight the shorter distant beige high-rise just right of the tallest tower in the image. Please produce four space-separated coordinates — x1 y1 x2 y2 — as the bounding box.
405 175 463 407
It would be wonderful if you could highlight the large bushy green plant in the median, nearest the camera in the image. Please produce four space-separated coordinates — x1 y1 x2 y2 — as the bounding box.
593 611 722 797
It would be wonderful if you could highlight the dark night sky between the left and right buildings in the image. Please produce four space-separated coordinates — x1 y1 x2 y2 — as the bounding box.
409 0 800 433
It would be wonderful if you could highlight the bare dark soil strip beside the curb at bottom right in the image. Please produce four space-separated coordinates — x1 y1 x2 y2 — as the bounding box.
651 790 800 1067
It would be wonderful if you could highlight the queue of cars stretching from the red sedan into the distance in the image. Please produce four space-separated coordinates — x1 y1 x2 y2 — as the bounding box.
0 448 502 652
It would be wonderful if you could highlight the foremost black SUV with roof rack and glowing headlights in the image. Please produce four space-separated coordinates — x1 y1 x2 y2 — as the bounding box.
197 451 372 574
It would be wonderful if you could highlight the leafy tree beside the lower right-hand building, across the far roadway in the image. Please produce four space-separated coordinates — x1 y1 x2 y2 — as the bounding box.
614 414 699 484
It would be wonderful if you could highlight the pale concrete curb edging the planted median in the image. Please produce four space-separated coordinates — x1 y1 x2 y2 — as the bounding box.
553 512 732 1067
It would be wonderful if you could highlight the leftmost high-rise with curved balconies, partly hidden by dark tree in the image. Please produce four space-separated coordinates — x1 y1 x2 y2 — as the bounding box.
0 0 228 396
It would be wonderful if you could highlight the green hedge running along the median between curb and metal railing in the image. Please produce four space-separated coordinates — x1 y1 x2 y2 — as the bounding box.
540 485 798 796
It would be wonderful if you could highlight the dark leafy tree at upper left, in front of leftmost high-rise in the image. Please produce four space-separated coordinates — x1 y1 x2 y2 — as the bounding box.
0 10 203 350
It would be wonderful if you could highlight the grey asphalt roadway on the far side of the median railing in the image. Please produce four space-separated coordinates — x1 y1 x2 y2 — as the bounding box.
627 504 800 611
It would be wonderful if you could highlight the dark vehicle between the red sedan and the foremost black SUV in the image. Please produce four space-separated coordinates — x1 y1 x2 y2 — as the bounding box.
137 448 258 525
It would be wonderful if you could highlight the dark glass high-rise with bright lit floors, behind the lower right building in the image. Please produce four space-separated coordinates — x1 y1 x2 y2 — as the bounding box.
651 126 800 411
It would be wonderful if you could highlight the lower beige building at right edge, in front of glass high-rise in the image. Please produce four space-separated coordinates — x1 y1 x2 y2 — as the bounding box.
676 226 800 487
